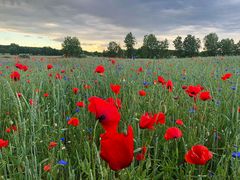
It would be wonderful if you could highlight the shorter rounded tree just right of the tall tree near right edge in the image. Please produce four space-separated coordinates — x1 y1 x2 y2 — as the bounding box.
219 38 235 55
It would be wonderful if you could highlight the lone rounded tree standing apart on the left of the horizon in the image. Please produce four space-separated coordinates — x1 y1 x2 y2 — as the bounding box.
62 36 82 57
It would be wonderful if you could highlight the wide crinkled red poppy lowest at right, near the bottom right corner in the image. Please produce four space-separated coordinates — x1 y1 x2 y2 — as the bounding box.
185 145 213 165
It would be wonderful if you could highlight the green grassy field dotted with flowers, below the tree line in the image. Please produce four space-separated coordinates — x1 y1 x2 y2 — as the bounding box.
0 57 240 180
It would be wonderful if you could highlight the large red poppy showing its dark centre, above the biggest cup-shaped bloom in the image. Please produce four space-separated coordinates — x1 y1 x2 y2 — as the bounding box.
88 96 121 132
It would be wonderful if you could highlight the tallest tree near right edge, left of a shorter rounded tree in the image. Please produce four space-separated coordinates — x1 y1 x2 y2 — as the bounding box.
204 33 218 56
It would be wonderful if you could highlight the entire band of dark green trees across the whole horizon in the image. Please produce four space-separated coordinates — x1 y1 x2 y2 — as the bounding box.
0 32 240 58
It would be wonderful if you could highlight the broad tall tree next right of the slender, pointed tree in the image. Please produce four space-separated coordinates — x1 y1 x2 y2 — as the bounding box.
142 34 159 58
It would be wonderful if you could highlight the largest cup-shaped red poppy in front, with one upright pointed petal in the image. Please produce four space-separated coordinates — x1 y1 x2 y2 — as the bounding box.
100 126 134 171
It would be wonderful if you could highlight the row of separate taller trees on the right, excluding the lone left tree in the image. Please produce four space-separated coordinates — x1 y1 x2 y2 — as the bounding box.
103 32 240 58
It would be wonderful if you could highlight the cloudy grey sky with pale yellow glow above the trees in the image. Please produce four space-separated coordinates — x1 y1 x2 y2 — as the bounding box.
0 0 240 51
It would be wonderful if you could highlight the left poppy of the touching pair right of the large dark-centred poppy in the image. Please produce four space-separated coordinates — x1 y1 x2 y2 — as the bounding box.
139 112 156 130
